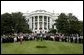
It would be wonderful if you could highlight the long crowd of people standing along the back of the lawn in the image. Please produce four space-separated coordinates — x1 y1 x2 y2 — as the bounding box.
1 33 83 44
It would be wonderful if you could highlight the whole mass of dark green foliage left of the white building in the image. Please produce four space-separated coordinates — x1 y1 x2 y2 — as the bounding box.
1 12 32 34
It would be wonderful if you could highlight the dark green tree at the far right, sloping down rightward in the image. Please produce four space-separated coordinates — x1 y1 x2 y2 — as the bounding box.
68 13 83 36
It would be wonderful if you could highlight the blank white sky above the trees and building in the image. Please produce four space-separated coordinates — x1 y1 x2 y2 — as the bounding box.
1 1 83 20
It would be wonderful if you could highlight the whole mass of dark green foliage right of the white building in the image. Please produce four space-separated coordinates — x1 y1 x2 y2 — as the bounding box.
55 13 83 35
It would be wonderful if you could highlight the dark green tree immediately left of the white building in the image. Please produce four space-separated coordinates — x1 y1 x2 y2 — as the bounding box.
11 12 29 33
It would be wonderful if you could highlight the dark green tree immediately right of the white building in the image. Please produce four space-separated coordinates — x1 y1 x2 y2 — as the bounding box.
56 13 68 33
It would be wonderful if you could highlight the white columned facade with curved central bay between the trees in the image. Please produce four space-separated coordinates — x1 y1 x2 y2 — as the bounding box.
24 10 58 33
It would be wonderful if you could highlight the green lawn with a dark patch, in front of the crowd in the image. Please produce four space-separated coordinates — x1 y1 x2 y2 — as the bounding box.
1 40 83 54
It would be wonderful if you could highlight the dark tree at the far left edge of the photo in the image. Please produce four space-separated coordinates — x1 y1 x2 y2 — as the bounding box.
1 13 12 34
